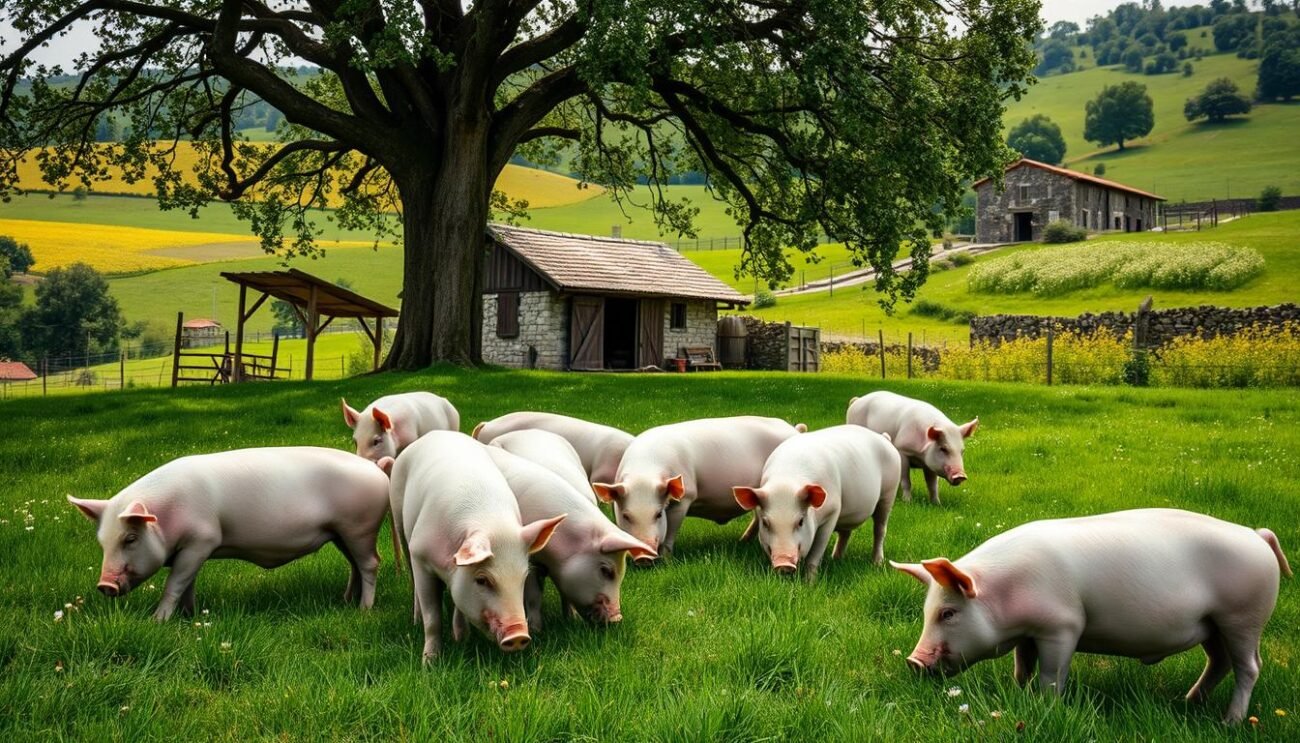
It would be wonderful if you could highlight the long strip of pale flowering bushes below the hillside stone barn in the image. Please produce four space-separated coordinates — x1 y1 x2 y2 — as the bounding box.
966 243 1264 296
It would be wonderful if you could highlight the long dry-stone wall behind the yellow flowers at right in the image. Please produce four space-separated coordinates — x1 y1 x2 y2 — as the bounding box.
971 304 1300 348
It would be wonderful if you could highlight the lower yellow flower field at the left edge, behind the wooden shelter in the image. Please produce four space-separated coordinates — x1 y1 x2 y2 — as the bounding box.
0 220 265 274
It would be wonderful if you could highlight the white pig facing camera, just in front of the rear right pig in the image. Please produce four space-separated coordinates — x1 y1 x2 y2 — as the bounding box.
733 426 901 582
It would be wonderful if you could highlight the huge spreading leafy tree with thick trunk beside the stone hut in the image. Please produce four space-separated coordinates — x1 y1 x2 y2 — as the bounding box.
0 0 1040 368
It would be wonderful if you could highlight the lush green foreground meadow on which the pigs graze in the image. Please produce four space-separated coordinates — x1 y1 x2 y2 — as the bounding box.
0 370 1300 742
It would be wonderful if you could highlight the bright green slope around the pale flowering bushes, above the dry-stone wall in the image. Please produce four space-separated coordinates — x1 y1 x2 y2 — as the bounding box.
753 212 1300 343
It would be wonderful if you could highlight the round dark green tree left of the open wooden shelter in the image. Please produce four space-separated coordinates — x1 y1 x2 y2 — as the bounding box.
21 264 124 359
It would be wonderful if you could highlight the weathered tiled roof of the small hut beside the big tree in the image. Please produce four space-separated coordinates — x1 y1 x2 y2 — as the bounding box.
488 225 750 304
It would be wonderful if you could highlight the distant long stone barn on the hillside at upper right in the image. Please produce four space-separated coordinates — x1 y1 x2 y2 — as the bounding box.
974 158 1165 243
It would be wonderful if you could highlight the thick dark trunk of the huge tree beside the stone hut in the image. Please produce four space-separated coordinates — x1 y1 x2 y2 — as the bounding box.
385 126 491 369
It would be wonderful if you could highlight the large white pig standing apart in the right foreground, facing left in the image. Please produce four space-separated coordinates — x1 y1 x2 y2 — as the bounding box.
892 508 1291 722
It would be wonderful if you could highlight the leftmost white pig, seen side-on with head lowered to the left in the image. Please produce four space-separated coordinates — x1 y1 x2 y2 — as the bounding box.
68 447 389 621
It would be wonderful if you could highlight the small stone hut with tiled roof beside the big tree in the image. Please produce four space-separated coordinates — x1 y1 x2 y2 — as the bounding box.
482 225 750 370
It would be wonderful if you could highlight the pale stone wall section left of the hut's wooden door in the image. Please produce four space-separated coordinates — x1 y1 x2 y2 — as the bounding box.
482 291 568 369
